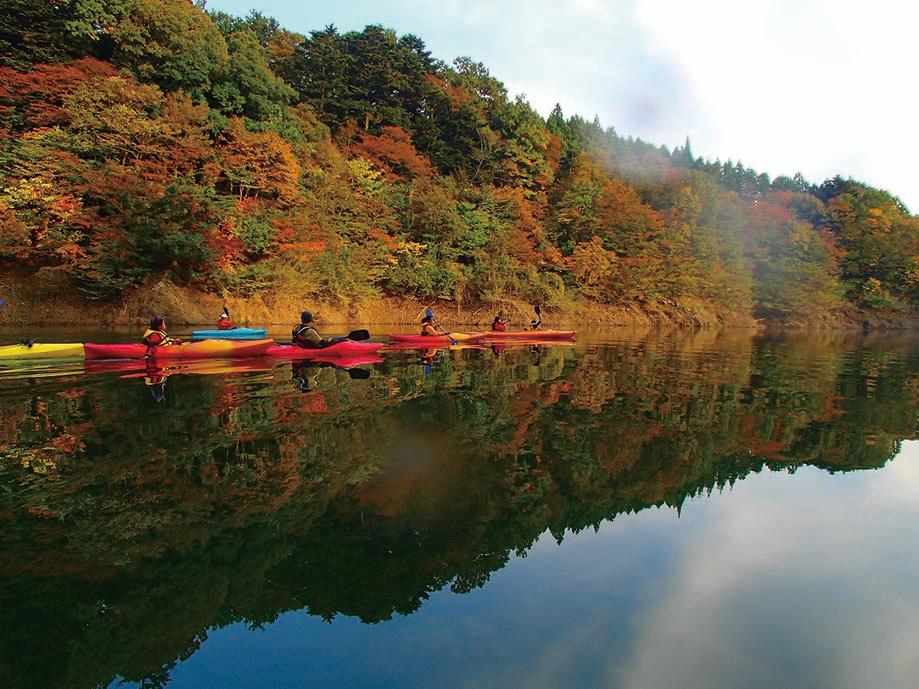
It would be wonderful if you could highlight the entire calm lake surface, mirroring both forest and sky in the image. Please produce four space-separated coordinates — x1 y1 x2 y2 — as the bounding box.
0 331 919 689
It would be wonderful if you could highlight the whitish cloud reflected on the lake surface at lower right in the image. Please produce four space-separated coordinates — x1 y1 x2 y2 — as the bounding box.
609 443 919 689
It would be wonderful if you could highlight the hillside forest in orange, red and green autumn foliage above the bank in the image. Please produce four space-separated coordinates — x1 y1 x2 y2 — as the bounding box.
0 0 919 322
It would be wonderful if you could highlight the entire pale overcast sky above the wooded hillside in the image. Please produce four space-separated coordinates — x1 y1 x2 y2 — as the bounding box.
207 0 919 213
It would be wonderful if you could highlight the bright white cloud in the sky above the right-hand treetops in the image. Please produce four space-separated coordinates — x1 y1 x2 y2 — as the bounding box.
636 0 919 210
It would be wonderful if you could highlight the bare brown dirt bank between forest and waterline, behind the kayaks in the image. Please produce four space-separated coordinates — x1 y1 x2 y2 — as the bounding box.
0 275 919 329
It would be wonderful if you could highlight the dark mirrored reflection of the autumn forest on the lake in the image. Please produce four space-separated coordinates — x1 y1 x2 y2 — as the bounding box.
0 339 919 689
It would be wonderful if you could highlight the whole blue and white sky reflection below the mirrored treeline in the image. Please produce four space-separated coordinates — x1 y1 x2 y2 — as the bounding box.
165 441 919 689
